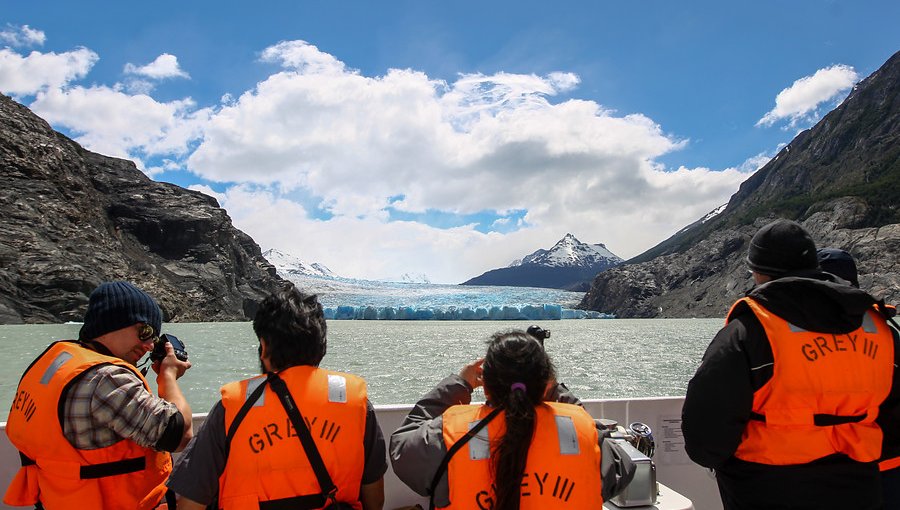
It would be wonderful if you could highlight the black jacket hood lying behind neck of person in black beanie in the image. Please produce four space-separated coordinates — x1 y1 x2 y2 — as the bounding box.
747 271 878 334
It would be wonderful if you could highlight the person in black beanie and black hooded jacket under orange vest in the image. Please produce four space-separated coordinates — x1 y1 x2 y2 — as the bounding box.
682 220 900 510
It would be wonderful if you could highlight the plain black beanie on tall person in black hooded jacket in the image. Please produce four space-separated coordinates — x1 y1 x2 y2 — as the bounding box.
747 220 819 277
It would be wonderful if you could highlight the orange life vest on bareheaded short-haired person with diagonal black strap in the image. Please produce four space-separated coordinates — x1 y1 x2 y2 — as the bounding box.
219 366 367 510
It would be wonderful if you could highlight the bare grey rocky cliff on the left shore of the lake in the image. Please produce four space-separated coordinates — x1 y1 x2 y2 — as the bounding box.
0 94 282 324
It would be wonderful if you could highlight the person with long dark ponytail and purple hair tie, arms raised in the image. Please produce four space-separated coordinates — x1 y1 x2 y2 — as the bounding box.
390 330 634 510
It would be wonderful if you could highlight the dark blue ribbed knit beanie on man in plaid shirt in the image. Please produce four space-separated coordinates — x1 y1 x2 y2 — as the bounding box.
78 282 162 341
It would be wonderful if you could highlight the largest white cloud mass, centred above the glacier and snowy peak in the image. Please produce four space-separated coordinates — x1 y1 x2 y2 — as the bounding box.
181 41 747 282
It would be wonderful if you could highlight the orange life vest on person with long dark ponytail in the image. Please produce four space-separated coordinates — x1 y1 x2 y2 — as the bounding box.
443 402 603 510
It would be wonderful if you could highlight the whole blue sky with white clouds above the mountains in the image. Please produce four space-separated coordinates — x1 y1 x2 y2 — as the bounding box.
0 0 900 283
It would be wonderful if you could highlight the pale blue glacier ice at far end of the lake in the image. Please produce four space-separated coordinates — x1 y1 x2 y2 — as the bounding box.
279 271 614 321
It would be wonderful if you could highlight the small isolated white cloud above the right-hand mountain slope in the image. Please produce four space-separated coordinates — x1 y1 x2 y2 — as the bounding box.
756 65 859 127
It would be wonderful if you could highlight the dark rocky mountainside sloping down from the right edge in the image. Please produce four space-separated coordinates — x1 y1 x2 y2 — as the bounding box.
580 48 900 317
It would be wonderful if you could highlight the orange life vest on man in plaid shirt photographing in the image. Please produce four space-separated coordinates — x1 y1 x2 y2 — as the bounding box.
3 341 172 510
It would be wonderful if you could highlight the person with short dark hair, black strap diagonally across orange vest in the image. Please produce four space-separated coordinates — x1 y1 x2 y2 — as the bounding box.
169 284 387 510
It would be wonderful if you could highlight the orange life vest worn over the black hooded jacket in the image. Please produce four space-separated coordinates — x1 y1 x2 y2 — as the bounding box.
729 298 894 465
